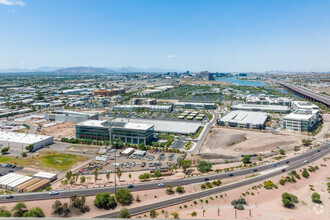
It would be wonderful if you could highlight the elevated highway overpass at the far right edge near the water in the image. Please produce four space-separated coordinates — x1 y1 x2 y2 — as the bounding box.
278 82 330 108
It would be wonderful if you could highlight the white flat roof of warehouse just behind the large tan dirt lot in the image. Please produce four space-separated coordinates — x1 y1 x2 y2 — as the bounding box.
220 111 268 124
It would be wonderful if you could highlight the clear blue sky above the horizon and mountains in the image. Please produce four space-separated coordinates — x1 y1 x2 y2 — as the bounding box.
0 0 330 72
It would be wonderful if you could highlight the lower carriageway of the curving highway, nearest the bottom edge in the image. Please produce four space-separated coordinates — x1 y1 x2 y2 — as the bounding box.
97 149 326 218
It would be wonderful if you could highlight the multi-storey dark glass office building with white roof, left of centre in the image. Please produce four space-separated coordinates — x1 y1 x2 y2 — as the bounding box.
76 120 154 145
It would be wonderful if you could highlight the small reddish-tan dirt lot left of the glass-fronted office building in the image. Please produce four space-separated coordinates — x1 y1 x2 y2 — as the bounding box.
38 122 76 140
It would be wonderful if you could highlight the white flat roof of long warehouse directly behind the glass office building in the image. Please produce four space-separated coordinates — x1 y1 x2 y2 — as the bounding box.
113 118 202 134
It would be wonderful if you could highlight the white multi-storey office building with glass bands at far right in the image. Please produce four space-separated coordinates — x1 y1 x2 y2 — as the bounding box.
283 109 319 132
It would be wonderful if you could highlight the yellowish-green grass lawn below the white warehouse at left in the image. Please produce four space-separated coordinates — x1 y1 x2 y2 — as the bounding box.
0 151 88 171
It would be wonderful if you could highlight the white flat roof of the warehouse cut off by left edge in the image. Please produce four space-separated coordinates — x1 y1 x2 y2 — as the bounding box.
0 131 53 144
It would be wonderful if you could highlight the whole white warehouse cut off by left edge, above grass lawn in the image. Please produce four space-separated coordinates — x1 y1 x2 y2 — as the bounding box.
0 131 53 151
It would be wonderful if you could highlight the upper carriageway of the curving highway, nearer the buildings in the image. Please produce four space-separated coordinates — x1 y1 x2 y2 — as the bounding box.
0 145 329 203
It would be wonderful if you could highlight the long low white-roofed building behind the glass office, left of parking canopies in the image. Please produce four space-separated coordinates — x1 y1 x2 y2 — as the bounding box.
113 105 173 112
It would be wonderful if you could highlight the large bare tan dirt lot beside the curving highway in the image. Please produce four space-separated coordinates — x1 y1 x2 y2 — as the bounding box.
200 128 301 156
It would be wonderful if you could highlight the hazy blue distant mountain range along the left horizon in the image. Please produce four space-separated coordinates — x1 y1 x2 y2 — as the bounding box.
0 66 182 74
